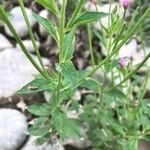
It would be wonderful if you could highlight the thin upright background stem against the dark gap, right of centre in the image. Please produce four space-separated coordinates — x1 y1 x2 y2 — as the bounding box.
87 24 95 67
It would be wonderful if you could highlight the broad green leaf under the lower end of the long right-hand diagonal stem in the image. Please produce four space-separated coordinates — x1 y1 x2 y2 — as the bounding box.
80 78 101 92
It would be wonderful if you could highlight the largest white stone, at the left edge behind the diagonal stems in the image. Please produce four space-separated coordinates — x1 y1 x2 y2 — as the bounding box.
0 48 49 98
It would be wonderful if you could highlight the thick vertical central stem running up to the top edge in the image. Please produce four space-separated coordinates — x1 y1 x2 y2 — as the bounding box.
59 0 67 62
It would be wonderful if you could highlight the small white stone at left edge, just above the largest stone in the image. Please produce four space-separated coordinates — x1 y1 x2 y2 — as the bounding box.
0 34 13 50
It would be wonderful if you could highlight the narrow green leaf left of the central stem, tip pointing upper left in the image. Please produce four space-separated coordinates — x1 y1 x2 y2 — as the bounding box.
33 13 57 41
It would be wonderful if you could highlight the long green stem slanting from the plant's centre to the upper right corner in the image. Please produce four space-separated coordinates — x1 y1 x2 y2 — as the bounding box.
78 8 150 84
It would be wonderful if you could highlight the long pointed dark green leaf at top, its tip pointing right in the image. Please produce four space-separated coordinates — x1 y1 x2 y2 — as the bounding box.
67 11 108 28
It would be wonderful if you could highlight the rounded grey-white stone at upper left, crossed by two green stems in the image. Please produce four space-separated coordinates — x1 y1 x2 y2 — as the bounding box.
4 7 36 37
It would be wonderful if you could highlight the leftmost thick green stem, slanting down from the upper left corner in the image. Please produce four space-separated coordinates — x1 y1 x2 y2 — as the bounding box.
0 7 48 79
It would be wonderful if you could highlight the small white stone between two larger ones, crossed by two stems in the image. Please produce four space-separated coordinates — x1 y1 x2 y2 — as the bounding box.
16 40 40 53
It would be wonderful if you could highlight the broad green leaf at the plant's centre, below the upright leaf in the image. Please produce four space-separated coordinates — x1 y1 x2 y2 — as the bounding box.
57 61 78 86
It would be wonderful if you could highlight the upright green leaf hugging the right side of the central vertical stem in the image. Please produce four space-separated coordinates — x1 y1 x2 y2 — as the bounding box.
62 32 75 62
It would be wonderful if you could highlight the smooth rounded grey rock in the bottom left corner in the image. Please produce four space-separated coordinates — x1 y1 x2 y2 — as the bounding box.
0 108 27 150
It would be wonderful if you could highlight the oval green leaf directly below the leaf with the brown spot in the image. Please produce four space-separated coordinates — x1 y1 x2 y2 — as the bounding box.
27 103 51 116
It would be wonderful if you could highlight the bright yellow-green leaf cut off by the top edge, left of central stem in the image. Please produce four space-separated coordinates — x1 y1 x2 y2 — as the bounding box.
36 0 58 16
